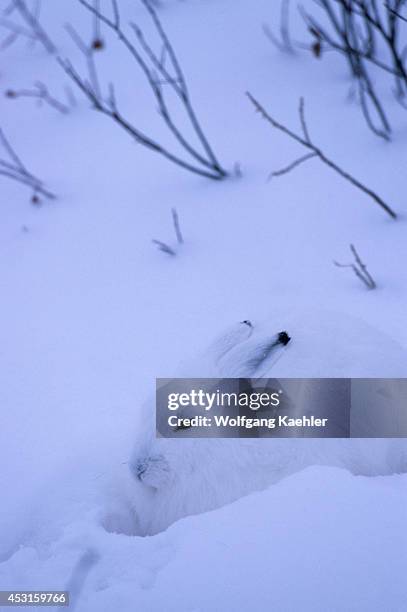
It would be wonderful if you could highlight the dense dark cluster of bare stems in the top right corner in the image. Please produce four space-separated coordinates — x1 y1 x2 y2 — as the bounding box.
266 0 407 140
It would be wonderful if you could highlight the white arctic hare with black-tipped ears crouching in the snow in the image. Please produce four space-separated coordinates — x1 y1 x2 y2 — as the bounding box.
126 315 407 535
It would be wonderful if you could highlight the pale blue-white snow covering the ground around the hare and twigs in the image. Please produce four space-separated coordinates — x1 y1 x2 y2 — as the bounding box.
0 0 407 612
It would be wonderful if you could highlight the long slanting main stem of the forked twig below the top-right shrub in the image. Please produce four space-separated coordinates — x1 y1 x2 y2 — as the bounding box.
247 92 397 219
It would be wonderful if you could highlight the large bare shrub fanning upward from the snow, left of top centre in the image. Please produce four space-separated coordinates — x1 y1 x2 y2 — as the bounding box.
59 0 227 180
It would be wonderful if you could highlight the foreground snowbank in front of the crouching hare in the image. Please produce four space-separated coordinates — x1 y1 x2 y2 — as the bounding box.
2 467 407 612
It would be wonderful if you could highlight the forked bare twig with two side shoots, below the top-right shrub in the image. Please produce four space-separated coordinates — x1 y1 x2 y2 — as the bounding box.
247 93 397 219
